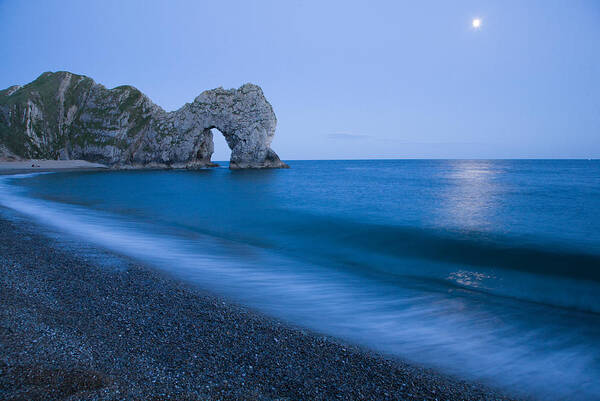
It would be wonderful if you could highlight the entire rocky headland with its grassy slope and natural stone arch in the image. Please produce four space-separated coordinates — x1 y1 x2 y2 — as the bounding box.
0 71 287 169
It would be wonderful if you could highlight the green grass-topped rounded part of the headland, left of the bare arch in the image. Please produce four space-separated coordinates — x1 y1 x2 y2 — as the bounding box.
0 71 150 159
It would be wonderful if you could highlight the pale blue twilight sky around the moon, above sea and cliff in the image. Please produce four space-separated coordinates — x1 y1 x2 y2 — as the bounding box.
0 0 600 160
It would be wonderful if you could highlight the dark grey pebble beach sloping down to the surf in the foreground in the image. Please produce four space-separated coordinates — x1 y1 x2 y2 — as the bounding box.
0 208 509 400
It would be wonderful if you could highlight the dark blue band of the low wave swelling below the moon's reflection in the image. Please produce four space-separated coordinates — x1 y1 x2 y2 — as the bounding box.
268 214 600 281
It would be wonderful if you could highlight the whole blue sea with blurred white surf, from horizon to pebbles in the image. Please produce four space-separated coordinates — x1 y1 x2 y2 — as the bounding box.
0 160 600 400
